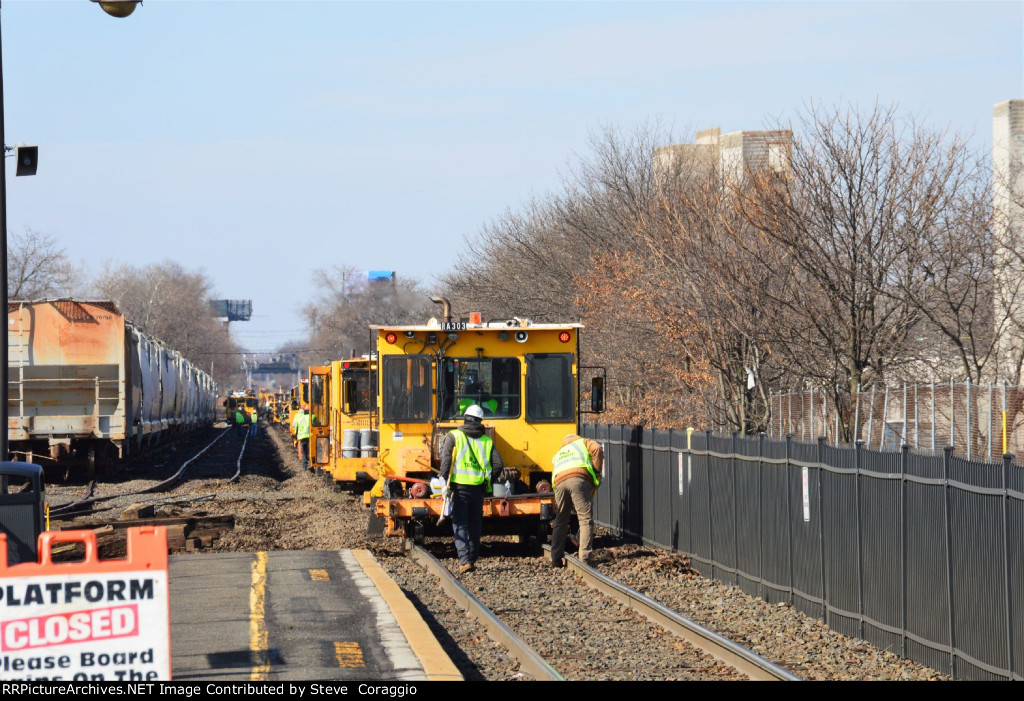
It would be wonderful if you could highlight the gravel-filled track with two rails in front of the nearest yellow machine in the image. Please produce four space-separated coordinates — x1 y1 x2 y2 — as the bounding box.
410 545 800 681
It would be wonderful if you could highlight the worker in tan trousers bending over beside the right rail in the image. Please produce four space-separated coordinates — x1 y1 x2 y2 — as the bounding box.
551 433 604 567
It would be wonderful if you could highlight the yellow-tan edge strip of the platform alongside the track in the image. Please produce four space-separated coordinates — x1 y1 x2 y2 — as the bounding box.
352 550 464 682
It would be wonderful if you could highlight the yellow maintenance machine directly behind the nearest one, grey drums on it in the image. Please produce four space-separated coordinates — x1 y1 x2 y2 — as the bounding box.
309 357 377 491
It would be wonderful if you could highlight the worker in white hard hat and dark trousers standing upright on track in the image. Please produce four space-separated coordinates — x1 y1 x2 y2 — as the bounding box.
440 404 518 573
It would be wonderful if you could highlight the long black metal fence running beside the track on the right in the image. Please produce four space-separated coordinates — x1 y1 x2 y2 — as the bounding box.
584 425 1024 680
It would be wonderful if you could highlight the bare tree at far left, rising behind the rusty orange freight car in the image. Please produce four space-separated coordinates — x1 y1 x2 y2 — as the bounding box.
7 228 81 300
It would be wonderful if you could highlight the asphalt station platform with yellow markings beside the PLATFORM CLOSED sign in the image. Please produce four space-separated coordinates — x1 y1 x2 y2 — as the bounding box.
169 551 462 682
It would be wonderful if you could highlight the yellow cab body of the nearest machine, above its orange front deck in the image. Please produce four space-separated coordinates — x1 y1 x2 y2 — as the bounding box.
371 320 582 488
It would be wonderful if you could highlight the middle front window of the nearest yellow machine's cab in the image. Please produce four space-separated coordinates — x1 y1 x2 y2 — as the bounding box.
441 358 522 420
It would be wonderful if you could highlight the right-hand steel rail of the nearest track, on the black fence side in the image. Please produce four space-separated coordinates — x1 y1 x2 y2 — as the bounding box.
544 544 801 682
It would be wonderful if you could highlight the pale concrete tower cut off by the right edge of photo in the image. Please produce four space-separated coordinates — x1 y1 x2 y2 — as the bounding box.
992 99 1024 385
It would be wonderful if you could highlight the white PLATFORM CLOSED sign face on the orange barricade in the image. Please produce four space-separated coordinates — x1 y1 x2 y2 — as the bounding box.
0 570 171 682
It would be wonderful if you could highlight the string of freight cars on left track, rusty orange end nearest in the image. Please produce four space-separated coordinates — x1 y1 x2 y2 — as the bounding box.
7 299 217 473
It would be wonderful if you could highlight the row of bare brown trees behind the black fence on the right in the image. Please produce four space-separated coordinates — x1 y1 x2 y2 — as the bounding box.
443 104 1024 433
